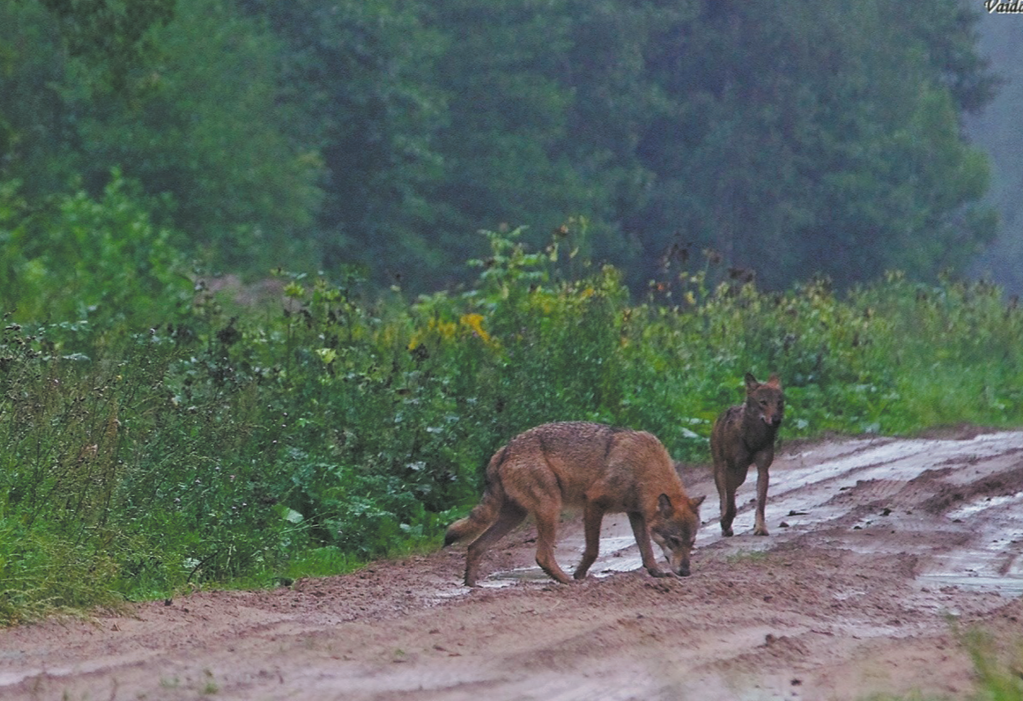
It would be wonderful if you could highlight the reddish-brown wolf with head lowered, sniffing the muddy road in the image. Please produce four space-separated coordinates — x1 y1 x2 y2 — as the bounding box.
444 423 704 586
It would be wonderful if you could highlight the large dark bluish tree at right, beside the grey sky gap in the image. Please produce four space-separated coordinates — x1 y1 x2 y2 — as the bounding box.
637 0 990 286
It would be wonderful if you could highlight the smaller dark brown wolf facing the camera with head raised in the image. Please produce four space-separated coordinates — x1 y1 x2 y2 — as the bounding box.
710 373 785 535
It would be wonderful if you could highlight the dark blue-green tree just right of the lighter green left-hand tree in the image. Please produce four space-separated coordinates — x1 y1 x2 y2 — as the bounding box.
243 0 450 286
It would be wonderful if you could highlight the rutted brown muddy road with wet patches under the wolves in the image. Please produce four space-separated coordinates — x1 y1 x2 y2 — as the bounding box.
0 431 1023 701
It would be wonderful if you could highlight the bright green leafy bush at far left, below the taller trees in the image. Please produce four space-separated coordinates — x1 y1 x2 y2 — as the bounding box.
0 171 192 328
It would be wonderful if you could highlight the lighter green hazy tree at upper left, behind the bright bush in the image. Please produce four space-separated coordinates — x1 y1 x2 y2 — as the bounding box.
71 0 321 272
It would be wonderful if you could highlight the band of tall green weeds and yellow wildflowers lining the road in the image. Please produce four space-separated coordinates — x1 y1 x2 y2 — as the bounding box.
0 223 1023 621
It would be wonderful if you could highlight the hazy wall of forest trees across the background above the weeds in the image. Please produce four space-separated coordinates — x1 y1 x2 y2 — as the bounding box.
0 0 994 292
